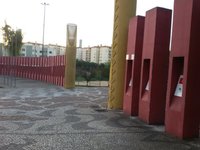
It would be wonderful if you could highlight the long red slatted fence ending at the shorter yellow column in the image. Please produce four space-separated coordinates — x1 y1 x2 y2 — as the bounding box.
0 56 65 86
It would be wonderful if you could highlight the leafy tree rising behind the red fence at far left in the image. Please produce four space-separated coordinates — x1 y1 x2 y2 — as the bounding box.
2 23 23 56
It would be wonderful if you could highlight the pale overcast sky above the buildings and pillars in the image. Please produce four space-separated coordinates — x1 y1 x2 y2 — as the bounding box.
0 0 174 46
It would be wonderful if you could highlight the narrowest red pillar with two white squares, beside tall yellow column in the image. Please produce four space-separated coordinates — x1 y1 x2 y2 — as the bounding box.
123 16 145 116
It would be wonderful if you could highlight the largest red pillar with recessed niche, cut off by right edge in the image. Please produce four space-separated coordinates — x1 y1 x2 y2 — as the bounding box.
165 0 200 138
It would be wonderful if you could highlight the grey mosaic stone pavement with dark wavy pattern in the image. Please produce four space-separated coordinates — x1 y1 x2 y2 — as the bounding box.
0 79 200 150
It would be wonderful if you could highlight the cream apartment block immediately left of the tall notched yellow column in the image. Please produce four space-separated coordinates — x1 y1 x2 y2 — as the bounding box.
99 46 111 64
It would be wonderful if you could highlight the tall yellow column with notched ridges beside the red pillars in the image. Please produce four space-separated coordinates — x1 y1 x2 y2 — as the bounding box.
108 0 137 109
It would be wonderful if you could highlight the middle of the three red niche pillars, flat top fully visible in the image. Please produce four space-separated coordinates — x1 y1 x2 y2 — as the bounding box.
139 8 171 124
